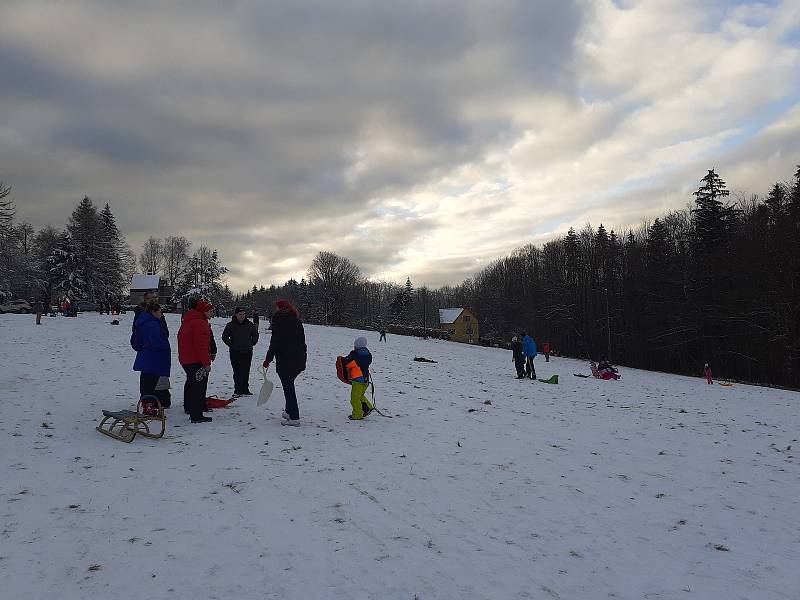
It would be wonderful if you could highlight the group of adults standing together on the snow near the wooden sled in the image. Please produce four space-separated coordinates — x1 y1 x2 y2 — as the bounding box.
131 292 307 425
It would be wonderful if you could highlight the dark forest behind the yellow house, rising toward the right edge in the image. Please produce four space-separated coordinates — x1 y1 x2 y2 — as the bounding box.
236 167 800 387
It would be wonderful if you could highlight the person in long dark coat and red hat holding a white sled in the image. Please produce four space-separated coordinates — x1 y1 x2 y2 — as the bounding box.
264 299 307 425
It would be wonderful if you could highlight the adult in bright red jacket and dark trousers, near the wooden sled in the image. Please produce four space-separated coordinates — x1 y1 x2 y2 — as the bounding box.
178 300 214 423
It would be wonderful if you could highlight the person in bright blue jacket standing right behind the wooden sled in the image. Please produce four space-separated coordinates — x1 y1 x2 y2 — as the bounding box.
133 302 172 408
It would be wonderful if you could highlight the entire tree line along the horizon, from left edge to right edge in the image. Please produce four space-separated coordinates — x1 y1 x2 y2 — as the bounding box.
0 167 800 387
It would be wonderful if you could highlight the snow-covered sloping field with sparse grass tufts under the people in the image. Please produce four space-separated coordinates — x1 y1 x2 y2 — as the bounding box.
0 314 800 600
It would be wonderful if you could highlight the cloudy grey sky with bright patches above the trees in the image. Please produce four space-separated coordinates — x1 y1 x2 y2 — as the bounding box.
0 0 800 290
